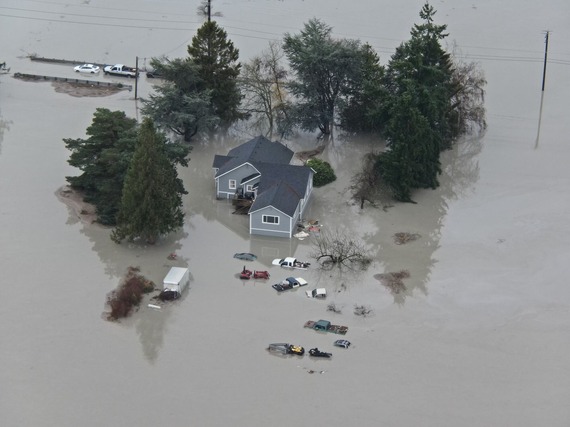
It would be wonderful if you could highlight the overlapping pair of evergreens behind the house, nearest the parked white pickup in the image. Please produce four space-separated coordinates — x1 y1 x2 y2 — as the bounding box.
143 21 245 142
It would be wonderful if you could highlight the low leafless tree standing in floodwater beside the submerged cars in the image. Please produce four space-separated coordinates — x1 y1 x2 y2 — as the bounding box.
311 229 372 269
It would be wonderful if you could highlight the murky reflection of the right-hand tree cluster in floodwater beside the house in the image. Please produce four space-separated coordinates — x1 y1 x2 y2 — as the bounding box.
304 135 482 305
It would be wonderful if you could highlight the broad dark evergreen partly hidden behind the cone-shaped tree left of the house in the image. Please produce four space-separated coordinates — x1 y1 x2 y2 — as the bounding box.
63 108 137 225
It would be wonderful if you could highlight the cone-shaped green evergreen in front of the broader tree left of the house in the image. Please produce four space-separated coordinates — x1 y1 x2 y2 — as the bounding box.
111 118 185 244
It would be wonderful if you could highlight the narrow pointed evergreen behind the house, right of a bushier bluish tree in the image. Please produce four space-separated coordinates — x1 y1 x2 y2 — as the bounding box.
188 21 243 129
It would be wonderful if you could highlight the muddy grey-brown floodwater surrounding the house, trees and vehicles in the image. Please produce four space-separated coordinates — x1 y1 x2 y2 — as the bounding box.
0 0 570 427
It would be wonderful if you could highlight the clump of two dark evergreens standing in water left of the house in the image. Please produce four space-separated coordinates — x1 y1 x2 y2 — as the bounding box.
64 108 189 243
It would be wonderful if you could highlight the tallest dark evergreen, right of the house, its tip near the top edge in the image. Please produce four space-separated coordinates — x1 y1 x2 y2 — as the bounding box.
374 2 453 201
